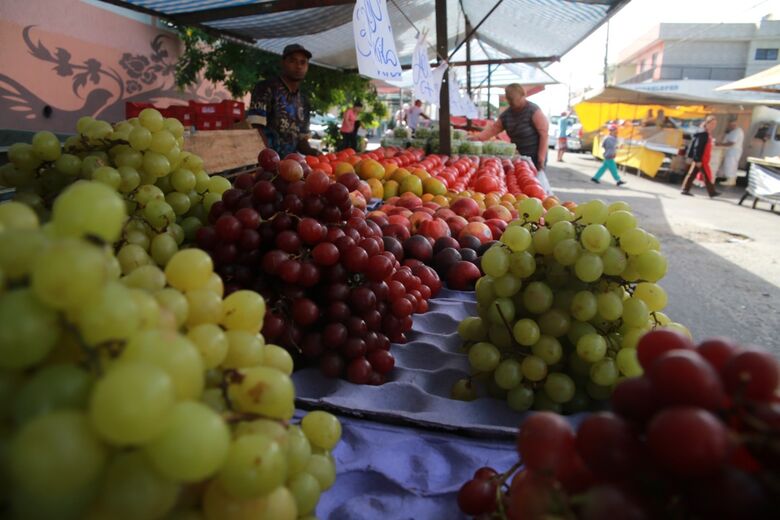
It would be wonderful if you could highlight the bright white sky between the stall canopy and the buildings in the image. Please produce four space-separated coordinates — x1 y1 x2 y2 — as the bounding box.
530 0 780 114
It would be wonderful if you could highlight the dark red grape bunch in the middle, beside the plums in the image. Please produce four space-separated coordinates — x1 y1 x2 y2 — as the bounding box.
196 150 441 385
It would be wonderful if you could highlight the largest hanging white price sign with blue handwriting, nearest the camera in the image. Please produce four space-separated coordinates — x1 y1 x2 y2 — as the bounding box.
352 0 401 80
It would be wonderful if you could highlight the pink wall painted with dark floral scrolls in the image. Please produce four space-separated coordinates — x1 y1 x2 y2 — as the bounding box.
0 0 236 133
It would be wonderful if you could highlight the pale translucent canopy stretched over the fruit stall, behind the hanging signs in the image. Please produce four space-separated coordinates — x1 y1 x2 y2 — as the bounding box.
104 0 630 69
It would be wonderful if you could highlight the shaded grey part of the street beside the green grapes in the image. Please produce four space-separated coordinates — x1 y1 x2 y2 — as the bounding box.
547 161 780 354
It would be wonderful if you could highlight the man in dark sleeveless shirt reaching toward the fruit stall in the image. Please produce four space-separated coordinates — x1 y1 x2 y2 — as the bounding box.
469 83 549 170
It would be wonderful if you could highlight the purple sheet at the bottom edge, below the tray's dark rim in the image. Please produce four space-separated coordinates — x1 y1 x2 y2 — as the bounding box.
308 417 517 520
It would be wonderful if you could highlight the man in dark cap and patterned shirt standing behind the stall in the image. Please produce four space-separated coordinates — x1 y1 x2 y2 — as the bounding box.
246 43 319 157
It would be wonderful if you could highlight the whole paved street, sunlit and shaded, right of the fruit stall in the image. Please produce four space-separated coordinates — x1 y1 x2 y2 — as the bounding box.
547 154 780 356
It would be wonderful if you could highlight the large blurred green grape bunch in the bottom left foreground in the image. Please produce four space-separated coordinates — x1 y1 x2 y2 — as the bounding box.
0 111 341 519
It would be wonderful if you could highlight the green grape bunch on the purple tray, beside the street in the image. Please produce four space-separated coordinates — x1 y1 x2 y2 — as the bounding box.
452 198 688 413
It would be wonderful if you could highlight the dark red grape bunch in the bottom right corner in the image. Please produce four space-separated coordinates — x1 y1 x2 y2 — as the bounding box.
458 330 780 520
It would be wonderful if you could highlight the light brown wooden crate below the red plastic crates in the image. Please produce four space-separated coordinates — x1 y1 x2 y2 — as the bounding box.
184 129 265 175
